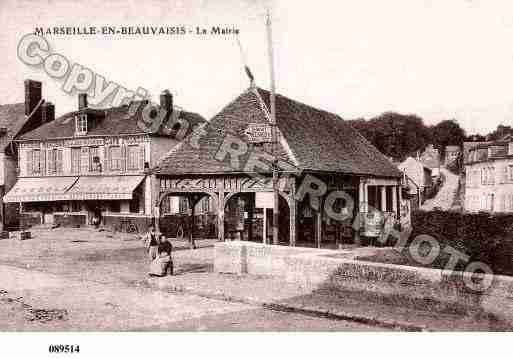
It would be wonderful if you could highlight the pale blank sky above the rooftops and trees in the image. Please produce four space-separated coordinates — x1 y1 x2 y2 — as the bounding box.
0 0 513 134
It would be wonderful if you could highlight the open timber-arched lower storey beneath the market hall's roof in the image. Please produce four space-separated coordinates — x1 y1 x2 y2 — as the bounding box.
155 173 401 249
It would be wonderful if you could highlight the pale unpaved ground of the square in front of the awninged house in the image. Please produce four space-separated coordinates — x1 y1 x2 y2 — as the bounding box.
0 230 376 331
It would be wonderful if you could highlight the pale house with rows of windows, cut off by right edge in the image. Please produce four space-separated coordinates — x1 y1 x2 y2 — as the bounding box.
464 140 513 213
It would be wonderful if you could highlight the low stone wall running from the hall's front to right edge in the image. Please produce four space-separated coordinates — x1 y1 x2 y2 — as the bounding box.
214 241 513 323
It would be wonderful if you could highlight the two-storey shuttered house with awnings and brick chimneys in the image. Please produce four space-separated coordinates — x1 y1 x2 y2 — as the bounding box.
3 81 204 231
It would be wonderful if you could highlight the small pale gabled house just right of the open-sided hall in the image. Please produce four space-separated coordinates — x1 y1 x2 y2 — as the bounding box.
397 157 433 204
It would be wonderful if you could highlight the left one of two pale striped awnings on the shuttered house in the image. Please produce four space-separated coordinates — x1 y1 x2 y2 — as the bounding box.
3 177 78 203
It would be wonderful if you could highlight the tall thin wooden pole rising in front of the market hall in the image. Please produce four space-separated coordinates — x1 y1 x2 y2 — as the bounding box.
266 9 280 245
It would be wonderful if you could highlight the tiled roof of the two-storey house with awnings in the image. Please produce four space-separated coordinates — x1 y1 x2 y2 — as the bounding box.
19 105 205 140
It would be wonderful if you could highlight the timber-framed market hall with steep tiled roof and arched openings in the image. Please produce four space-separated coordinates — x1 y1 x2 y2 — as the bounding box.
152 86 409 247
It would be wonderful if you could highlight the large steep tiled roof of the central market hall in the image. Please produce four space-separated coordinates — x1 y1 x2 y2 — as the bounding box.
154 88 401 177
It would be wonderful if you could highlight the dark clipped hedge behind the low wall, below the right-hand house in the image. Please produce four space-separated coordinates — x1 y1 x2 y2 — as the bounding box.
410 211 513 275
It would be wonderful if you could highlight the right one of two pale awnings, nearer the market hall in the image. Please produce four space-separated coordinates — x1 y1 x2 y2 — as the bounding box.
66 176 144 200
